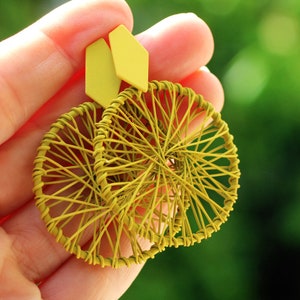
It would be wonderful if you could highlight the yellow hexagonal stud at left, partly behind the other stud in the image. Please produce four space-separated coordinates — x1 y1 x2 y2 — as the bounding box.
85 39 121 108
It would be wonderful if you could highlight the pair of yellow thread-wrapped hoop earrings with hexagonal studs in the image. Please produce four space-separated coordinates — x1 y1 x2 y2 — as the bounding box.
33 25 240 268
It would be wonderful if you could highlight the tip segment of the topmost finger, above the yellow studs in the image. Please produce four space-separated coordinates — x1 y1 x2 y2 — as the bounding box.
35 0 133 60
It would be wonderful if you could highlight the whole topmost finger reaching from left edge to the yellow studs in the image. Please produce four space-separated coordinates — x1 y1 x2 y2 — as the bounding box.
0 0 133 144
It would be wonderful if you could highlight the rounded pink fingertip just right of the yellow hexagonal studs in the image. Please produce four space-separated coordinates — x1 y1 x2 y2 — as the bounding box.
137 13 214 81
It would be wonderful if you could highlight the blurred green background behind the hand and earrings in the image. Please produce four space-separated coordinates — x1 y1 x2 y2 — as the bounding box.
0 0 300 300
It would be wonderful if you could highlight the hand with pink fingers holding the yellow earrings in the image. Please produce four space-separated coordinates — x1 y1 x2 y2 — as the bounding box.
0 0 224 300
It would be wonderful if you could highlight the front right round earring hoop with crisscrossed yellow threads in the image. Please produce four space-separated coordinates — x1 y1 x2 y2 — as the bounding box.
94 81 240 248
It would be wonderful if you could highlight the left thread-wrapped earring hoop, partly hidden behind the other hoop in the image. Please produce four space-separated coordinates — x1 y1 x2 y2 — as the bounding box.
33 102 163 267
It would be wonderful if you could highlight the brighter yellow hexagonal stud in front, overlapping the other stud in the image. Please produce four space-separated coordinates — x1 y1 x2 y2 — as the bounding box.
109 25 149 92
